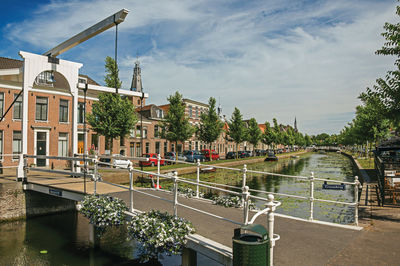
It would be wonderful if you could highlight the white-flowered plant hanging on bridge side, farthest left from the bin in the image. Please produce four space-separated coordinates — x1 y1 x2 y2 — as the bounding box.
80 195 128 229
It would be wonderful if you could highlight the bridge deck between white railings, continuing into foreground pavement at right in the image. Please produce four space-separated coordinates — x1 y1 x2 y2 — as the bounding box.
22 176 400 265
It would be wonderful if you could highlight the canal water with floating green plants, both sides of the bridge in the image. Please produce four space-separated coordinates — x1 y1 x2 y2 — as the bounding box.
0 153 355 266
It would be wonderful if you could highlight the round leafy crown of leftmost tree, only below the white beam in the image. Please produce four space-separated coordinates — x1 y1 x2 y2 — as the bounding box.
87 92 137 148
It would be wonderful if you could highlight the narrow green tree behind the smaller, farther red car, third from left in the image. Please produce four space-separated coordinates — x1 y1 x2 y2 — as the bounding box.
197 97 224 160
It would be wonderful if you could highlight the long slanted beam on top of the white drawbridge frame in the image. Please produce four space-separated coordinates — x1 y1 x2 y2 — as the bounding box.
43 9 129 57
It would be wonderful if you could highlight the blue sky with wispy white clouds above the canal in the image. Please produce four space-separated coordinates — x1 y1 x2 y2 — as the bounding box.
0 0 399 134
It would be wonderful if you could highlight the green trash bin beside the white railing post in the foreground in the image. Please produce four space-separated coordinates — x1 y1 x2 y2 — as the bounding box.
232 224 270 266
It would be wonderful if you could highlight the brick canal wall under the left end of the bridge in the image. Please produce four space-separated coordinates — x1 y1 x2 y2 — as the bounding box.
0 181 76 221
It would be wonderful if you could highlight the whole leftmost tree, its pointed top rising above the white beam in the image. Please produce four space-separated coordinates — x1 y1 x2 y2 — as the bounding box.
87 56 137 152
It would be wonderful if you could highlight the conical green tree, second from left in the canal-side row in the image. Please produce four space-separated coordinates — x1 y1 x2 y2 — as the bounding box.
161 92 194 159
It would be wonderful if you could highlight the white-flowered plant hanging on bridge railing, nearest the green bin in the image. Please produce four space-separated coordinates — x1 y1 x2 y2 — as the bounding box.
128 210 195 260
